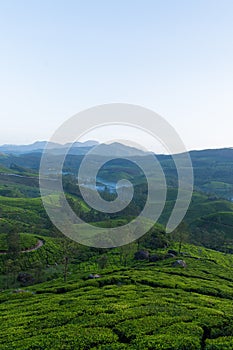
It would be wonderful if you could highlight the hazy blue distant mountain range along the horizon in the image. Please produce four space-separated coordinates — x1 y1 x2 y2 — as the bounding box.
0 141 233 201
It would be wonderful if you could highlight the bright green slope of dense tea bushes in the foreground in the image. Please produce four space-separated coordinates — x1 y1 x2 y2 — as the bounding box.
0 245 233 350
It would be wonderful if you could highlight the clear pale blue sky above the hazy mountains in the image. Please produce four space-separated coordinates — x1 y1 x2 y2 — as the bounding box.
0 0 233 150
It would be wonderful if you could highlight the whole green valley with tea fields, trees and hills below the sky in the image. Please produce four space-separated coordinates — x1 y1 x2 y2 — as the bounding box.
0 144 233 350
